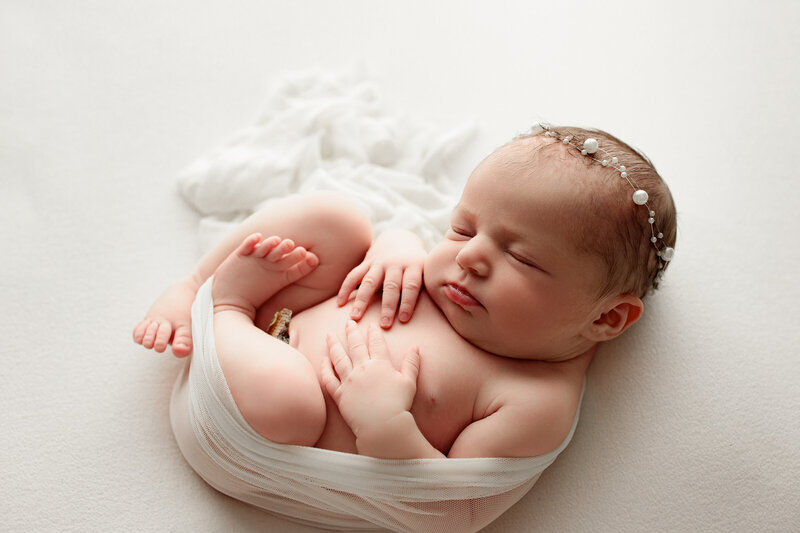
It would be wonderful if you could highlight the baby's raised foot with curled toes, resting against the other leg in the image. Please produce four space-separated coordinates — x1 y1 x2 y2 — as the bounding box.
211 233 319 319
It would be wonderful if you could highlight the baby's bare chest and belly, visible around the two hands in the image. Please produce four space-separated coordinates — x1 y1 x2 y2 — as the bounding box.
289 292 486 454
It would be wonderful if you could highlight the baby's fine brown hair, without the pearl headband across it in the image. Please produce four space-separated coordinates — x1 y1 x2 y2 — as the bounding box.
511 126 677 300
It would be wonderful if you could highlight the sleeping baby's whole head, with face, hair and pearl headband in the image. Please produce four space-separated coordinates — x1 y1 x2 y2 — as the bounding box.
425 122 676 361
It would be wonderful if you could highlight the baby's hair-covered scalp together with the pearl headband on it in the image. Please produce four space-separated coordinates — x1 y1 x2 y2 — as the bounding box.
504 125 677 298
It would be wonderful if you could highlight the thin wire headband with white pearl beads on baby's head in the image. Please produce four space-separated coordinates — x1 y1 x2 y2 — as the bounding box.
521 123 675 284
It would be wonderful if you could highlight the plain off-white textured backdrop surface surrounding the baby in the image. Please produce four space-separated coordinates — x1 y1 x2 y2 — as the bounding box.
0 0 800 533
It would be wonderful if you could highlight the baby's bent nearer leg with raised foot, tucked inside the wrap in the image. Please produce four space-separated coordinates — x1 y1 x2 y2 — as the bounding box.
211 234 326 446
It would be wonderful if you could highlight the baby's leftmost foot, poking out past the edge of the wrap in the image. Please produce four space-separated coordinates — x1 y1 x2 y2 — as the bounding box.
133 281 197 357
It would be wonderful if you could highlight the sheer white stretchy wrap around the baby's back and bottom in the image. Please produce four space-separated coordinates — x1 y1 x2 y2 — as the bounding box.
170 278 580 532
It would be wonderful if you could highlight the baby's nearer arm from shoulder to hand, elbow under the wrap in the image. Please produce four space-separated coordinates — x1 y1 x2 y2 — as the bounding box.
322 322 573 459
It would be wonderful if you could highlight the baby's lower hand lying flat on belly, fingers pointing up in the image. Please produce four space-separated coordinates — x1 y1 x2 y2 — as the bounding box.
322 320 420 438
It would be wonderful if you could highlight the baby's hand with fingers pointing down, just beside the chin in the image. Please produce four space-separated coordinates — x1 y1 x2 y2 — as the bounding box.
336 231 427 328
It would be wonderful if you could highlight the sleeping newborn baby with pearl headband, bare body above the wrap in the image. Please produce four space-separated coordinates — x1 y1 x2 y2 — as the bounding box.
133 126 676 459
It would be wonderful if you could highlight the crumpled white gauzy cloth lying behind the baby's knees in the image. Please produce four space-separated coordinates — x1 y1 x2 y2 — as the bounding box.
178 65 475 250
